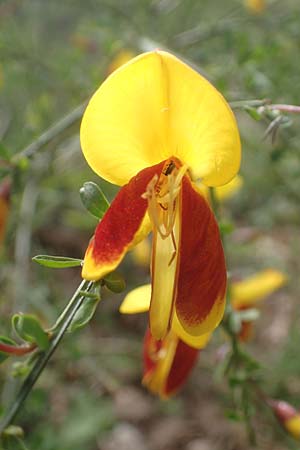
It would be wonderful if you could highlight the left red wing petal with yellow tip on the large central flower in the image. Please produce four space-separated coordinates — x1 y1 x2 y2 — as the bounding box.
82 162 164 280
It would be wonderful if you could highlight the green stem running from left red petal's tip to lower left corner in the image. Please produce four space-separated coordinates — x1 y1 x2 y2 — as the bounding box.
0 281 93 436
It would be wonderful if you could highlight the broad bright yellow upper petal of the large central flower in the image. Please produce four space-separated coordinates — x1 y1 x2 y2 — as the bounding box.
81 51 240 186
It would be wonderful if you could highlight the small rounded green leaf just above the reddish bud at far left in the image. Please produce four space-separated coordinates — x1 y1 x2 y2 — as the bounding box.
12 314 49 350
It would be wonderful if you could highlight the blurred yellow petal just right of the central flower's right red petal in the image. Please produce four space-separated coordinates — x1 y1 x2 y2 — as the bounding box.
231 269 287 309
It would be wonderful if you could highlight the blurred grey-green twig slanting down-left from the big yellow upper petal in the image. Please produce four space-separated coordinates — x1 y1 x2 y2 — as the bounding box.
13 102 87 163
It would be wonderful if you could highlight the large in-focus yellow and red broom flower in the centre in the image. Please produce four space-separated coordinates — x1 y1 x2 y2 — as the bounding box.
81 51 240 340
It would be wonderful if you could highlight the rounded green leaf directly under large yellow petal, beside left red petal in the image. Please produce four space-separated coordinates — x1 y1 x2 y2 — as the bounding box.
79 181 109 219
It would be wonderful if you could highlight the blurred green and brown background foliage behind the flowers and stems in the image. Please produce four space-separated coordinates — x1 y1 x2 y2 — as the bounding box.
0 0 300 450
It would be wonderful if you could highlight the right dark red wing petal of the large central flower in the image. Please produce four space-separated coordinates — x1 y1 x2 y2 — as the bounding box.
175 177 226 336
